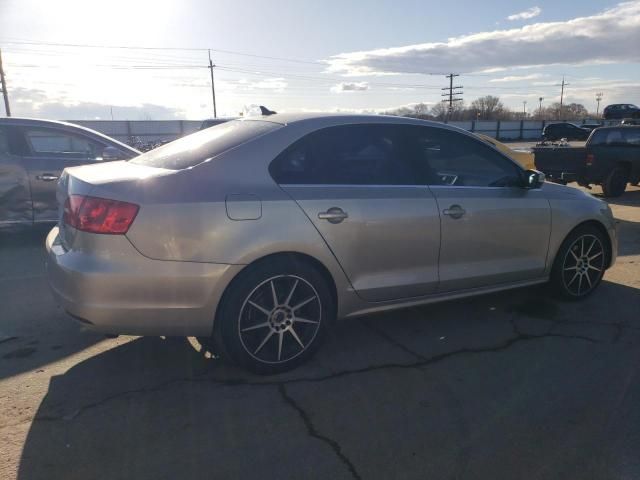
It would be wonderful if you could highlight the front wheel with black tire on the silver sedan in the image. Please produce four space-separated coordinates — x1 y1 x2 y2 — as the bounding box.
549 225 611 300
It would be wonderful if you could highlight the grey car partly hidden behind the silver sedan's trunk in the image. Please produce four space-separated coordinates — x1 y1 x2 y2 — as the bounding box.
0 117 140 227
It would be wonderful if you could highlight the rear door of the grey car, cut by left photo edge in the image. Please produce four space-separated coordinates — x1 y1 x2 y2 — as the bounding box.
0 126 33 226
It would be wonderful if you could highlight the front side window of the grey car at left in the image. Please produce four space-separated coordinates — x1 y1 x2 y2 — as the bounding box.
25 129 103 157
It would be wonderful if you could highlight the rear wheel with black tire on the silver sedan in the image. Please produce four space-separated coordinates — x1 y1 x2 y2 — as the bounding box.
213 257 336 375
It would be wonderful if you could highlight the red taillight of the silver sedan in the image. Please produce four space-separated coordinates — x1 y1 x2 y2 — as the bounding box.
62 195 140 235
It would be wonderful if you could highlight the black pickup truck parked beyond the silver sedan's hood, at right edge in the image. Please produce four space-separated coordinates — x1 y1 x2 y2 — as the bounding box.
534 126 640 197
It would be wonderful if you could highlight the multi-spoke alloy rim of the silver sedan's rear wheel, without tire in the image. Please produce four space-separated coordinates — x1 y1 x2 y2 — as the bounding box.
238 275 322 364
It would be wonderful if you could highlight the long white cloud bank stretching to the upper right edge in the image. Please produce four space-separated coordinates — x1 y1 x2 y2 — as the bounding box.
328 1 640 75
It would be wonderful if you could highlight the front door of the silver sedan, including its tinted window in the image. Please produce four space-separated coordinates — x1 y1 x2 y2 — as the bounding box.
422 127 551 292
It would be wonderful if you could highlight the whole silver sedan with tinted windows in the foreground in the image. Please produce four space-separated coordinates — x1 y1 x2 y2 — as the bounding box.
46 114 617 373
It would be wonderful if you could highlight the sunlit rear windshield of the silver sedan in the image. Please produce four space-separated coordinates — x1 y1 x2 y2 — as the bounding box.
130 120 281 170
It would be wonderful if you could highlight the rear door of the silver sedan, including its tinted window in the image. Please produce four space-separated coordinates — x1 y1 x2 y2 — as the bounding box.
270 124 440 301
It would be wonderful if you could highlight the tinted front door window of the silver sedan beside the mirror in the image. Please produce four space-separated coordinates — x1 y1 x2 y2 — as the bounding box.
417 127 521 187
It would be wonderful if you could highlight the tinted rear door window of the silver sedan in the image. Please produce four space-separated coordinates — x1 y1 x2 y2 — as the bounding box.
269 124 416 185
